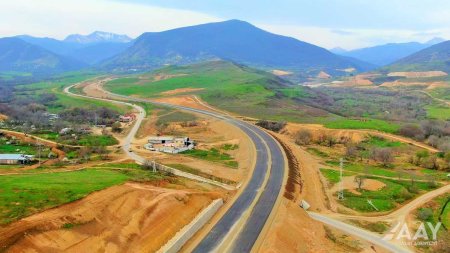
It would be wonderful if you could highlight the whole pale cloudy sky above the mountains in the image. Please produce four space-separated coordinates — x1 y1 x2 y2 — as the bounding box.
0 0 450 49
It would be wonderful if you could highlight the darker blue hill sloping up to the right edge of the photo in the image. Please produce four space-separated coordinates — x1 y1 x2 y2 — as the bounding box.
385 41 450 73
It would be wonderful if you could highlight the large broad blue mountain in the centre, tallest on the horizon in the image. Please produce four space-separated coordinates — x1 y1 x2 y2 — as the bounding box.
102 20 367 74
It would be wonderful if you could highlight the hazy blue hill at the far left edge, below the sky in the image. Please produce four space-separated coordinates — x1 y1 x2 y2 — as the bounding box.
0 37 85 75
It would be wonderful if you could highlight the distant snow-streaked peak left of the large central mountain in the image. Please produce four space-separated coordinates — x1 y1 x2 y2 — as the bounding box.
64 31 132 44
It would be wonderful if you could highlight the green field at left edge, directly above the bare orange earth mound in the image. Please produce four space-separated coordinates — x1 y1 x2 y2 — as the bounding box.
0 169 163 224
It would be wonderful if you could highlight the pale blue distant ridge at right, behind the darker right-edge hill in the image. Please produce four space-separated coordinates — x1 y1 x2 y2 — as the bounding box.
332 38 443 66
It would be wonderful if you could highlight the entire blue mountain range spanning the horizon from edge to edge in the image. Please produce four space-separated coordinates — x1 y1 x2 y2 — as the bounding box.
0 20 448 80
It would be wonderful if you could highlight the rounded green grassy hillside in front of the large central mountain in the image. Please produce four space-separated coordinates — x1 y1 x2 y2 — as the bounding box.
106 61 338 122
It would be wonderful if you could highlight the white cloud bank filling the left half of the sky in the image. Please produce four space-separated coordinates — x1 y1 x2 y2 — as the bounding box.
0 0 219 39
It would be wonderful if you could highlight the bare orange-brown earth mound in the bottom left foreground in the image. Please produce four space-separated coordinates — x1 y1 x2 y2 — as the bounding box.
0 183 221 252
